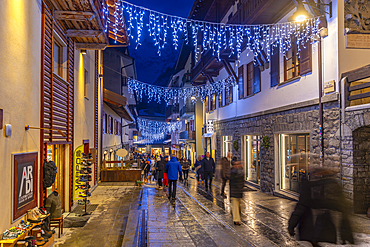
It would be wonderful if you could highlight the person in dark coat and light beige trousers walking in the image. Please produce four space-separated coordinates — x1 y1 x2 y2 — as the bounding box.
228 161 244 225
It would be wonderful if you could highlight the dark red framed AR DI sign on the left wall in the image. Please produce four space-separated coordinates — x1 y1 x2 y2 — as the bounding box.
13 152 38 221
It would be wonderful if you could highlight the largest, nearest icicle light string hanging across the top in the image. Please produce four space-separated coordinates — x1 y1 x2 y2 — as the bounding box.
114 0 320 61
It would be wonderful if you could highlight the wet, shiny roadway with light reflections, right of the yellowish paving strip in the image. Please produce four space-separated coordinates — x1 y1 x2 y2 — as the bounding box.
144 174 370 246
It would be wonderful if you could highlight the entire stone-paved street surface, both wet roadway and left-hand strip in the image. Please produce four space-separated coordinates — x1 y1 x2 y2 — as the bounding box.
54 174 370 247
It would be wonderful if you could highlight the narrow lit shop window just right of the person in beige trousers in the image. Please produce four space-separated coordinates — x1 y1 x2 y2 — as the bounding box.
243 135 261 184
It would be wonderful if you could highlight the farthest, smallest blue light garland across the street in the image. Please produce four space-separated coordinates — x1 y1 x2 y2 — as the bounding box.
137 118 183 143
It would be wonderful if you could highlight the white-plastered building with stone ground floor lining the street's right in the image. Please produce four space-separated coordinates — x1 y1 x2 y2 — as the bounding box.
174 0 370 213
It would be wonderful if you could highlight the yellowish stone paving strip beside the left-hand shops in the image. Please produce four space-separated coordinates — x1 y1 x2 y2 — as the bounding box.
54 186 140 247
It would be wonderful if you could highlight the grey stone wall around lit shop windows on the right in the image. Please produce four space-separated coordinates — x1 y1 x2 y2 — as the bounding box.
215 102 340 193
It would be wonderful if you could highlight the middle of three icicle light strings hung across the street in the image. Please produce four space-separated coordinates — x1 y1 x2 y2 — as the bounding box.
127 77 236 105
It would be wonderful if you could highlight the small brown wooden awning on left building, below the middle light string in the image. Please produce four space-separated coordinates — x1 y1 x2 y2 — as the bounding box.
103 88 134 122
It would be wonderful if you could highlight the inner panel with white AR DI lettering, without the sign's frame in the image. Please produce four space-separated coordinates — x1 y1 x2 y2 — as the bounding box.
18 162 35 208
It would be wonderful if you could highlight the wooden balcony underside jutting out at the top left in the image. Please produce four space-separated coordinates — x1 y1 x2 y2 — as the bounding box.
49 0 129 50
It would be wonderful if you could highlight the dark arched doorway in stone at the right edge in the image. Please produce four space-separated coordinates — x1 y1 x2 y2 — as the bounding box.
353 126 370 214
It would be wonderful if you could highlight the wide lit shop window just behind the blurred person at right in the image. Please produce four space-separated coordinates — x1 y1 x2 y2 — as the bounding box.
279 134 310 192
